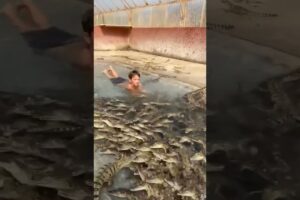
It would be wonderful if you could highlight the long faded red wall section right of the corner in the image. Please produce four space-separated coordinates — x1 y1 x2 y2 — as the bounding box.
129 27 206 63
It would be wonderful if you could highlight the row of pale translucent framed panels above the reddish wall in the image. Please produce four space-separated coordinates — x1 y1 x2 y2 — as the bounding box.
95 0 206 27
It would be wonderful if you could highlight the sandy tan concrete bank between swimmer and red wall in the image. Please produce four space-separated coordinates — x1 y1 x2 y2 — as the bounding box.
94 51 206 88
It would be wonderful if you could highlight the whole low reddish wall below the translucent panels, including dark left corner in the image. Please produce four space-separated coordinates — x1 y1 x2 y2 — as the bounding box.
94 26 206 63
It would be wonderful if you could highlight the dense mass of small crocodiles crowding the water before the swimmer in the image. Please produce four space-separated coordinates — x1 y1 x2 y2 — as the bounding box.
94 90 206 200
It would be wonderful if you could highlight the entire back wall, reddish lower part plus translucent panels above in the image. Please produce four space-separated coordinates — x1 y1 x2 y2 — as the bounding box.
95 0 206 63
